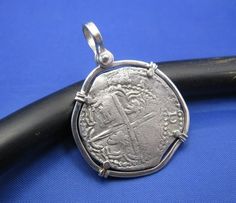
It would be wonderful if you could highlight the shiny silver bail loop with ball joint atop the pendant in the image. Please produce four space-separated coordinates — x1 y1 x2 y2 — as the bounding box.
83 22 114 67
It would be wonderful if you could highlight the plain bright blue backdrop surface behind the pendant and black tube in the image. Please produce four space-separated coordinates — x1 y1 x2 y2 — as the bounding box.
0 0 236 202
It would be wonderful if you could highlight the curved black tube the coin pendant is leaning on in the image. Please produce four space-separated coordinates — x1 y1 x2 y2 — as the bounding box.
0 57 236 171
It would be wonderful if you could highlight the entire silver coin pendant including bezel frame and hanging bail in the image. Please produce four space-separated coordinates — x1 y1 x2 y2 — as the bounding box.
72 23 189 177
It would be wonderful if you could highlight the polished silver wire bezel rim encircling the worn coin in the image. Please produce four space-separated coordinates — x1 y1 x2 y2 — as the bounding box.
71 60 190 178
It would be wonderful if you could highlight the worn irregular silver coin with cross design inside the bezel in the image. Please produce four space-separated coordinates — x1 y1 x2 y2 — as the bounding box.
78 67 185 171
